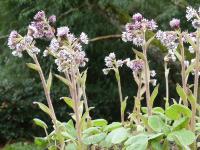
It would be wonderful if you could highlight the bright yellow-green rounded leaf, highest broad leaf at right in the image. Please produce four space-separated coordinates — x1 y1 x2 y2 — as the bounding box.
165 104 192 120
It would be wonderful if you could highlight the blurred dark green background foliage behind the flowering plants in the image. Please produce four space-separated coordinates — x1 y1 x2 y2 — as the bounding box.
0 0 200 143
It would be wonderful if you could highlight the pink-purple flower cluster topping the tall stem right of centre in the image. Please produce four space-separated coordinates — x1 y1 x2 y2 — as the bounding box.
122 13 158 46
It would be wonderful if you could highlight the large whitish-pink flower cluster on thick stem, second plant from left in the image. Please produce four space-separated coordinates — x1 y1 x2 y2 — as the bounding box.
43 26 88 72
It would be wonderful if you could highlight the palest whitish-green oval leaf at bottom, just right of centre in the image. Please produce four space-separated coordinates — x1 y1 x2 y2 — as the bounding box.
105 127 128 144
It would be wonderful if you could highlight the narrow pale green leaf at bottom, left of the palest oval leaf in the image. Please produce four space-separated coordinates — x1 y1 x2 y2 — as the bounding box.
83 133 106 145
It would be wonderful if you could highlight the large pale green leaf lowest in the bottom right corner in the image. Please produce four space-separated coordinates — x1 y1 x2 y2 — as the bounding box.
167 129 196 146
